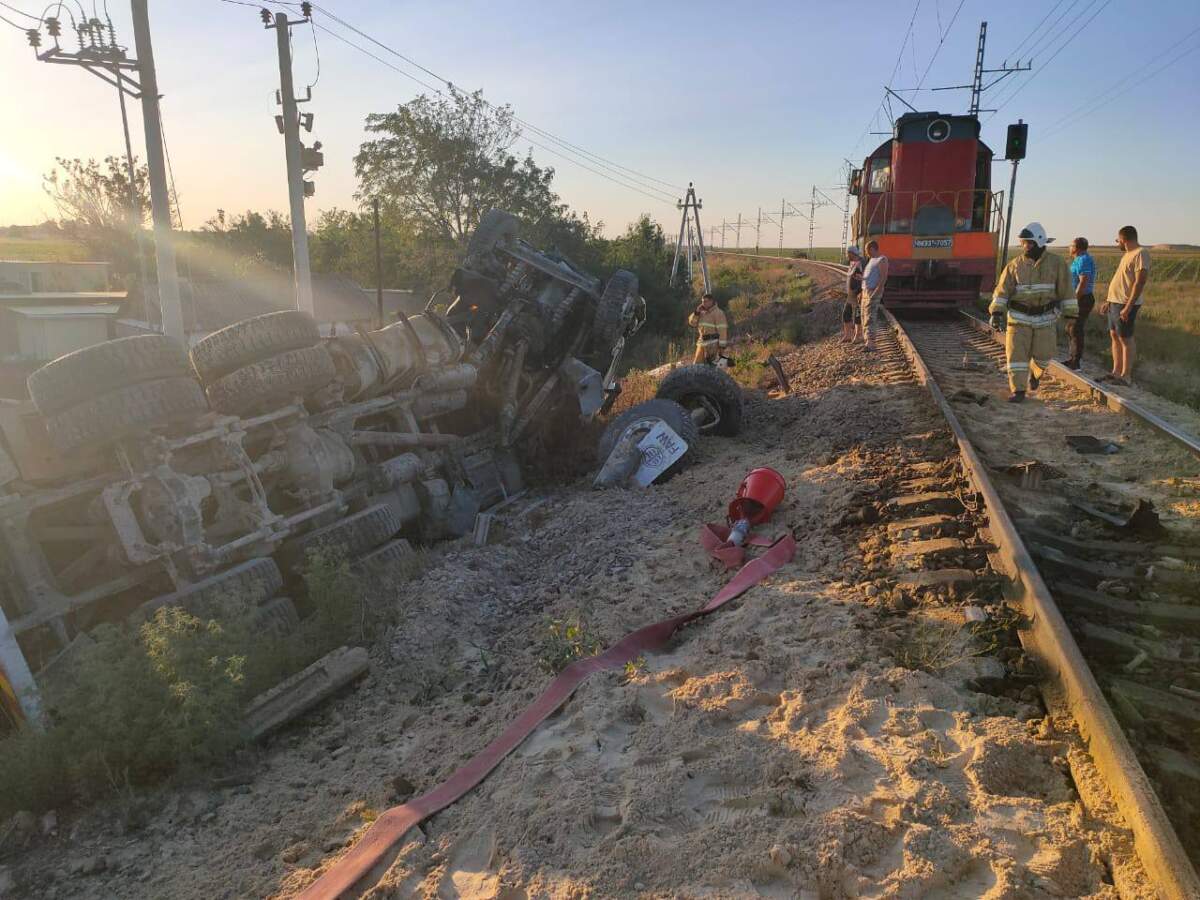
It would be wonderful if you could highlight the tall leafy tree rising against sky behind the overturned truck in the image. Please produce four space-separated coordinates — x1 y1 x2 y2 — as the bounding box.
354 88 580 246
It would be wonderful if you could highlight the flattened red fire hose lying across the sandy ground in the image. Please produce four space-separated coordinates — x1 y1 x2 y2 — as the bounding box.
300 524 796 900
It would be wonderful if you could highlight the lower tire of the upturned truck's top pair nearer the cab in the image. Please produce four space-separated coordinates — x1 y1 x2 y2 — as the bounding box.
206 344 337 415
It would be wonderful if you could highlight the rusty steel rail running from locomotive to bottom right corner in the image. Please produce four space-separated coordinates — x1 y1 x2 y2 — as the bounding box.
882 310 1200 900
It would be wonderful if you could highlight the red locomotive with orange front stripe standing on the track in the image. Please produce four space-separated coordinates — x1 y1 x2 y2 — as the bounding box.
850 113 1003 308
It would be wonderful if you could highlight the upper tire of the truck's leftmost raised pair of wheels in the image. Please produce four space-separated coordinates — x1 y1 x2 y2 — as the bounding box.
25 335 192 415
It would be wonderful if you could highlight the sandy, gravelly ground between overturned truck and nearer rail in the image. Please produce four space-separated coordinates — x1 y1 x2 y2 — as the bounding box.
7 278 1151 899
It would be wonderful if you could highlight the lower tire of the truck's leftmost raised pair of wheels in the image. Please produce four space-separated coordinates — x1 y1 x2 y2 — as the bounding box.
46 377 208 454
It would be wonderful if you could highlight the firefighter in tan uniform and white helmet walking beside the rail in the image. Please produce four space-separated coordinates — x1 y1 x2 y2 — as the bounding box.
988 222 1079 403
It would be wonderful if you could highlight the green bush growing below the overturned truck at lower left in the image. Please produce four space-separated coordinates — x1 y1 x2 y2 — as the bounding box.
0 556 364 816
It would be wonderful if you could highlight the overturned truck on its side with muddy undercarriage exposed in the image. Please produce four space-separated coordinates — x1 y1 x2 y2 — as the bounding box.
0 210 740 722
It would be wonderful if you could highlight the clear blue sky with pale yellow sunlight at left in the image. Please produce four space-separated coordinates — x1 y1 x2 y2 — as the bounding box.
0 0 1200 247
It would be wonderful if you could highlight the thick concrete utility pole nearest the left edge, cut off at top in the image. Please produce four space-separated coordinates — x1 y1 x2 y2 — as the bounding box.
131 0 185 341
